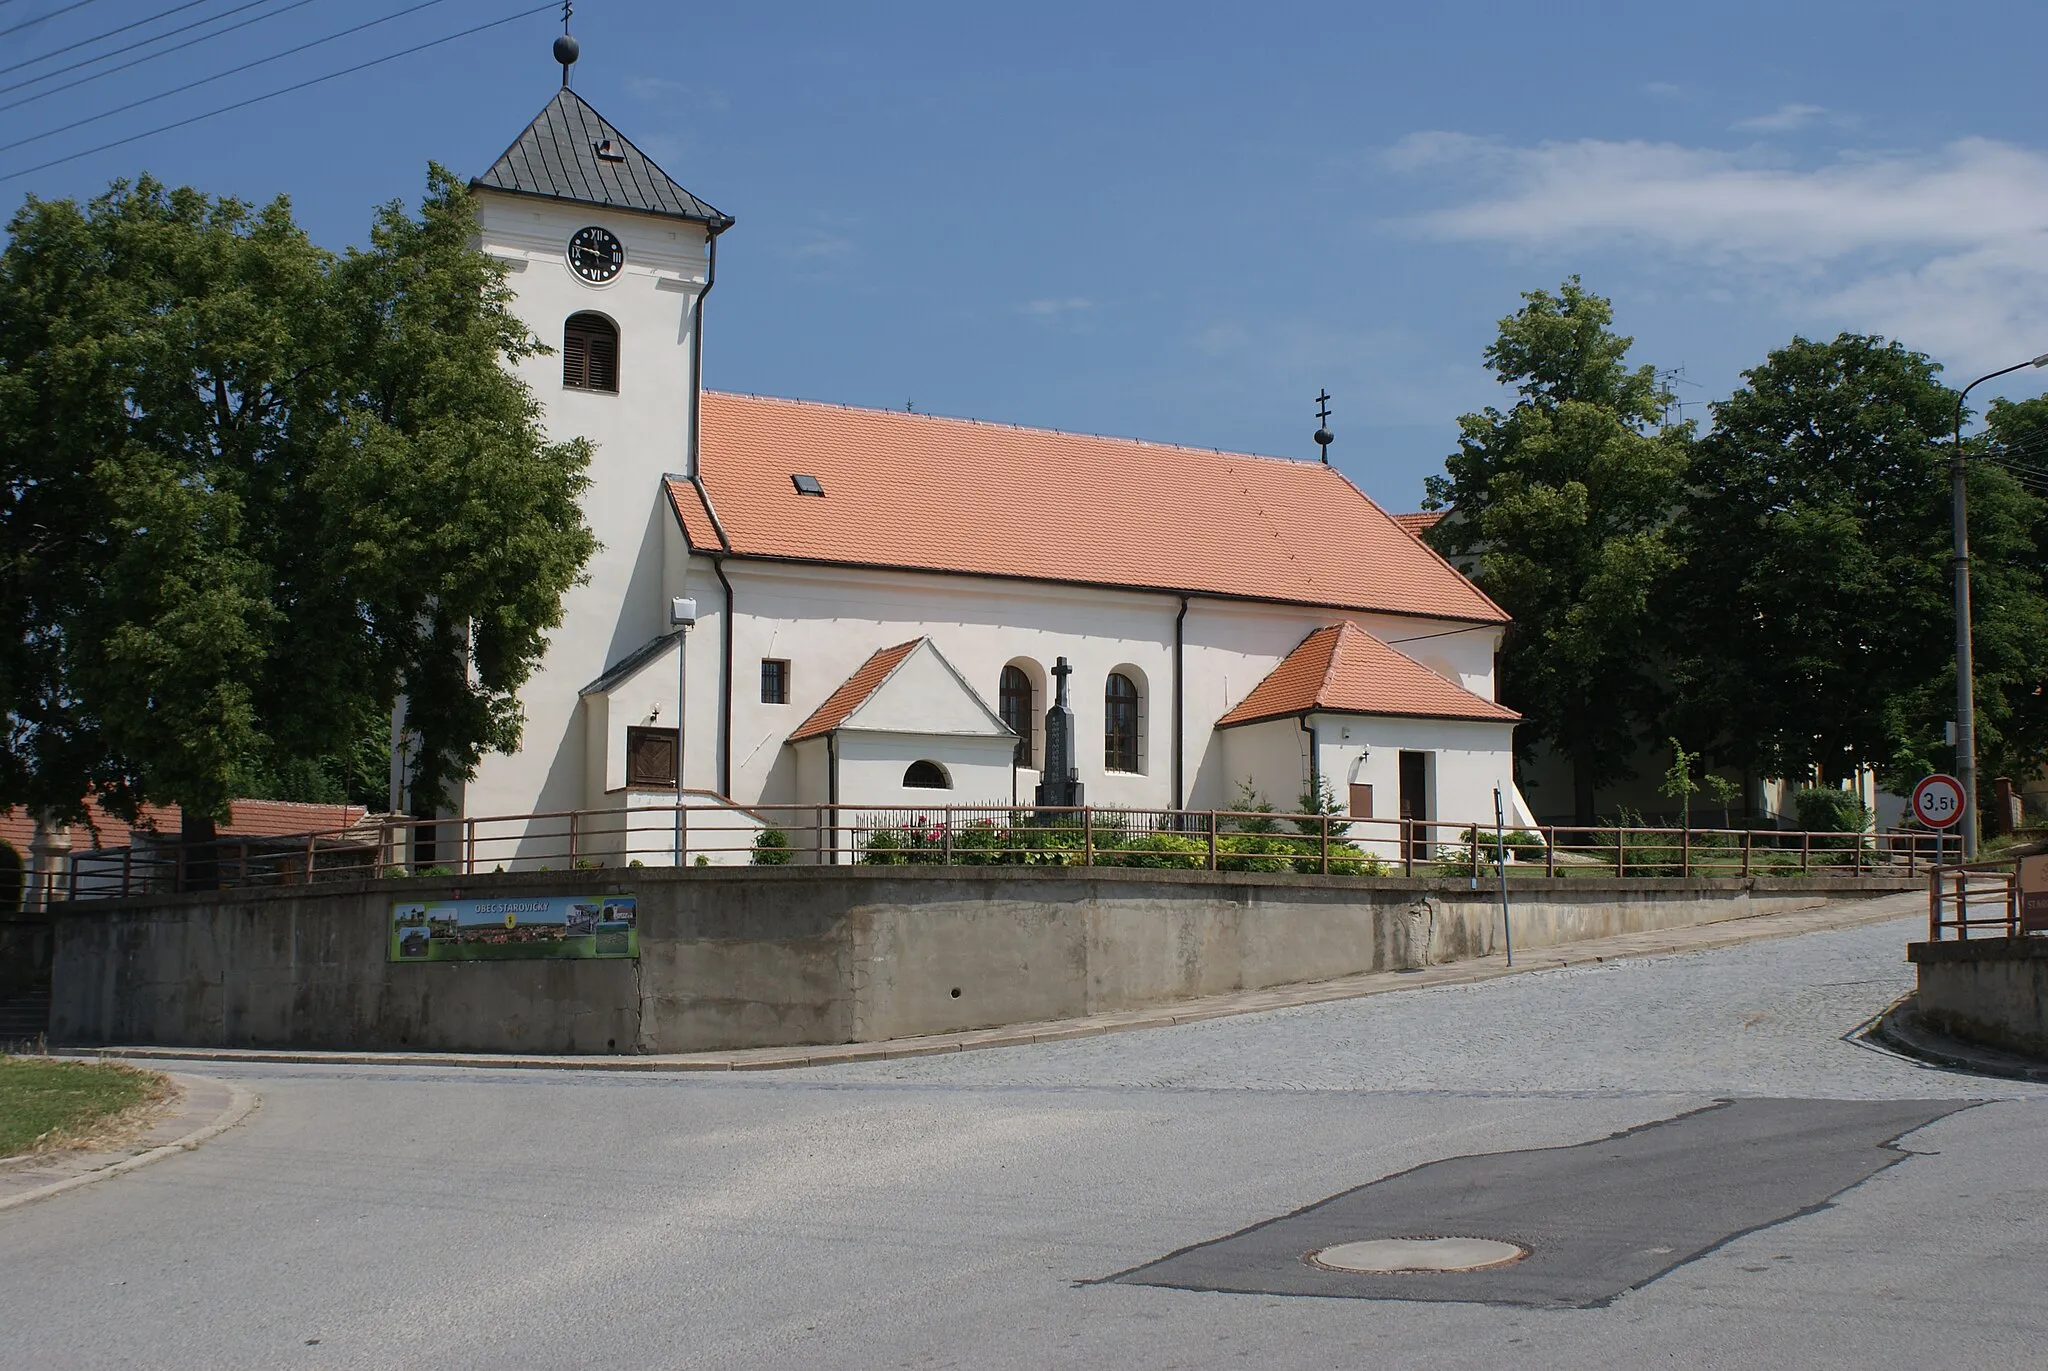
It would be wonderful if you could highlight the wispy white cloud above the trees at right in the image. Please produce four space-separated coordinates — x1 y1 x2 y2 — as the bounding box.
1386 133 2048 363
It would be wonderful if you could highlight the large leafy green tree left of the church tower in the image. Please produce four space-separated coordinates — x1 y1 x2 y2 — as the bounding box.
0 168 592 860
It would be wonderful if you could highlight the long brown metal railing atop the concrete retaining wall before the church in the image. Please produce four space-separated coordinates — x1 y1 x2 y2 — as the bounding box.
48 793 1939 900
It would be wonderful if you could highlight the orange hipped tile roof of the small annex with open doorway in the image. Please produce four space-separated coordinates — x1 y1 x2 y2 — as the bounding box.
1217 623 1522 728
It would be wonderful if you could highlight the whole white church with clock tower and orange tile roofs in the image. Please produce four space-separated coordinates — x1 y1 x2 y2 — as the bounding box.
451 61 1528 865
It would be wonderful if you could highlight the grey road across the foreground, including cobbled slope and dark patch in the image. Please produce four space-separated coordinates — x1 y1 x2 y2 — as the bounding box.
0 920 2048 1371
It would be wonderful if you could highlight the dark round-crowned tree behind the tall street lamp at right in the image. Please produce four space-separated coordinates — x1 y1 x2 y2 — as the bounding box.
1669 334 2048 789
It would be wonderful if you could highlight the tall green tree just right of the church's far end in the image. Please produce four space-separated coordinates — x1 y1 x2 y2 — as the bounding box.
1425 277 1692 824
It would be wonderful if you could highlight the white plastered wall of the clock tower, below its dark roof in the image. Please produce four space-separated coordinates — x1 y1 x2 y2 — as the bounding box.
465 191 717 836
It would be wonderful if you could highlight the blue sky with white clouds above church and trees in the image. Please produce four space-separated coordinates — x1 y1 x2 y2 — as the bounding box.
0 0 2048 508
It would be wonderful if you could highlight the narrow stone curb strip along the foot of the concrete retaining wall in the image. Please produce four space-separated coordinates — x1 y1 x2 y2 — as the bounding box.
64 891 1925 1072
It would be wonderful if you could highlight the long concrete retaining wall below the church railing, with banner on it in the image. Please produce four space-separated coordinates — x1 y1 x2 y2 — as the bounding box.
51 867 1915 1051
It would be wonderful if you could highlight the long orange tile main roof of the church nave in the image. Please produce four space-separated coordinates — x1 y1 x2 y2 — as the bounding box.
668 391 1507 623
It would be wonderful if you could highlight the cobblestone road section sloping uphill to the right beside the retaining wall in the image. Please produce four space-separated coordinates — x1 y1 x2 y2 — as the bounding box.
813 918 2048 1098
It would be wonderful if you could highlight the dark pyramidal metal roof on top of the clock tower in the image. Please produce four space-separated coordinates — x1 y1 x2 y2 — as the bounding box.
469 86 733 234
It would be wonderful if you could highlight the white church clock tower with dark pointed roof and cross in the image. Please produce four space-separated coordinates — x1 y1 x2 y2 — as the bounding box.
461 45 733 814
